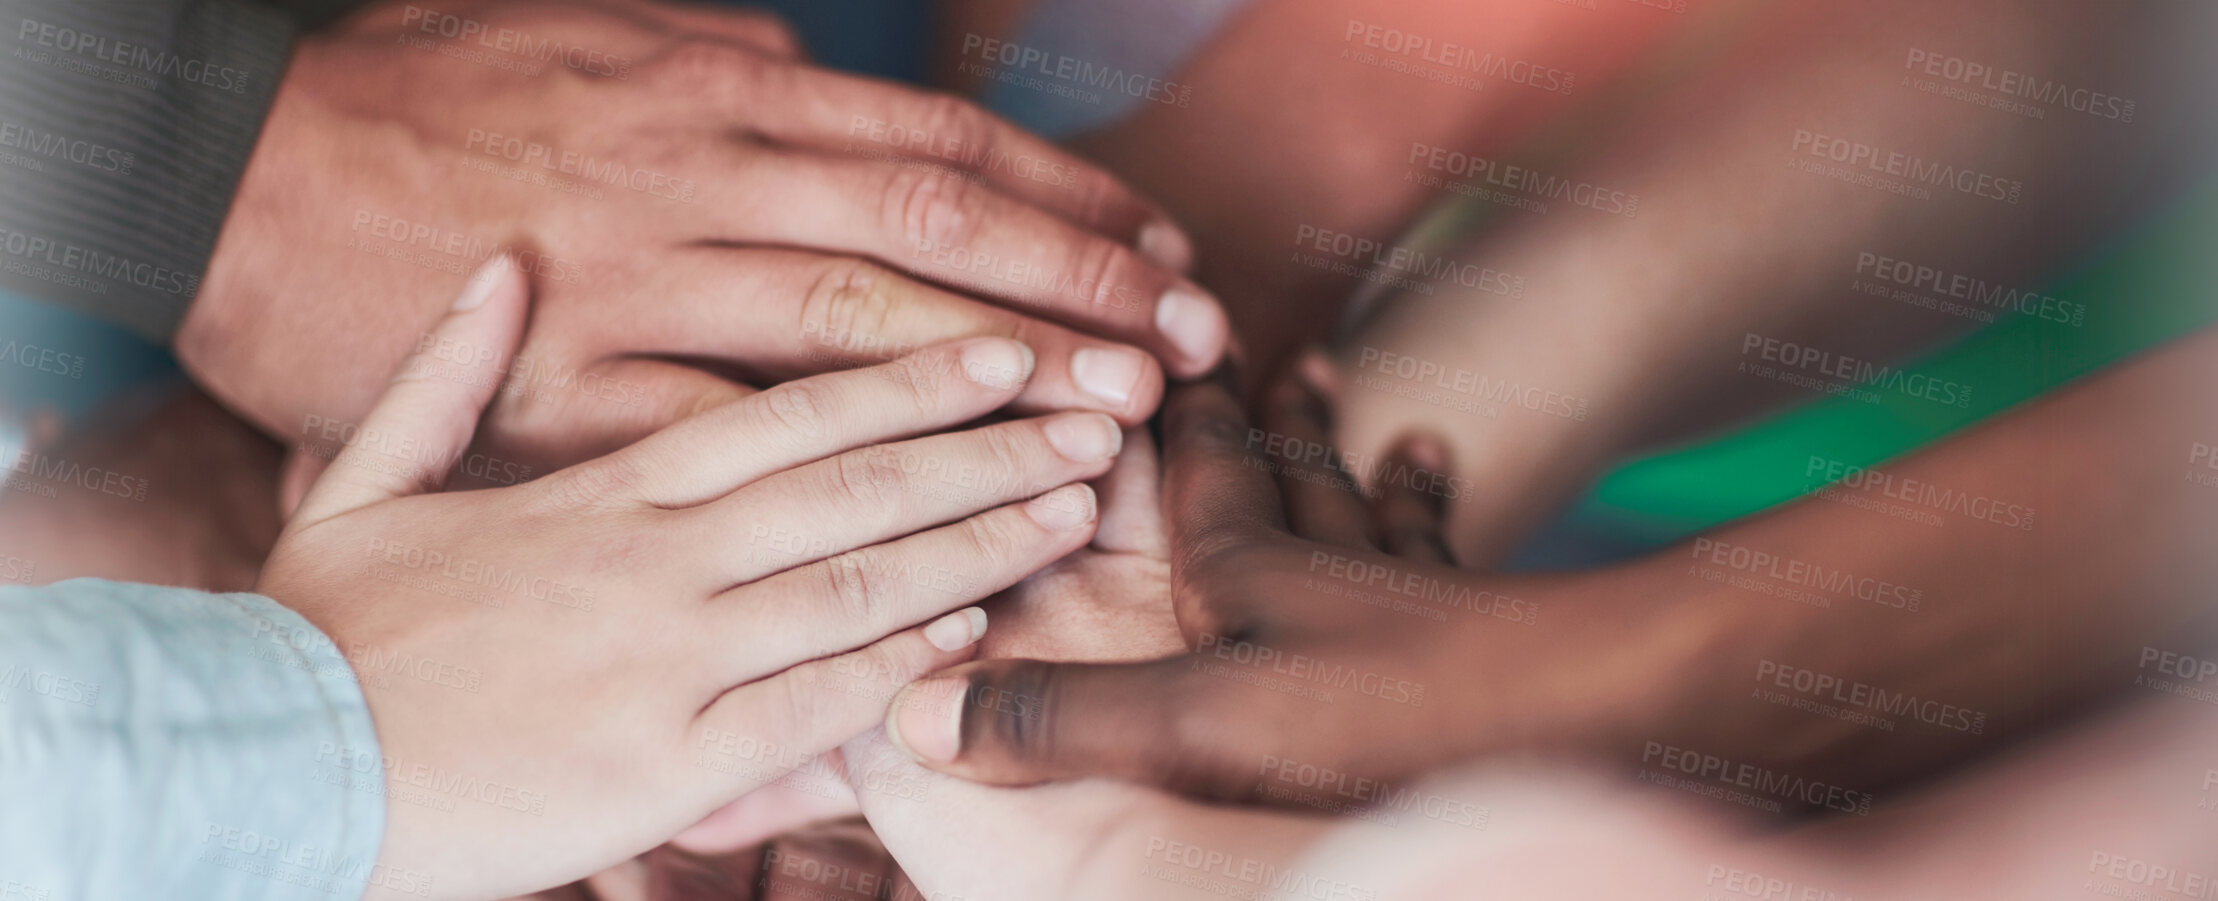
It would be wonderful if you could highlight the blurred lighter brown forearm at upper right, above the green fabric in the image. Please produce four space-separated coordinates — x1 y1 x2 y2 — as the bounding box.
1342 4 2209 557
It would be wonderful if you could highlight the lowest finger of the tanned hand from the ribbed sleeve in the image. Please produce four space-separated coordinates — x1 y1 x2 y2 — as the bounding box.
608 249 1162 426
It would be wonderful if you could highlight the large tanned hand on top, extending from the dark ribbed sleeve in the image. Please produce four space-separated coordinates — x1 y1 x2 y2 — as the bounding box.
190 0 1227 470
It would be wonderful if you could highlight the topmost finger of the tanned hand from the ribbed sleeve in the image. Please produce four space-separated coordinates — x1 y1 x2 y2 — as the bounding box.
681 49 1193 273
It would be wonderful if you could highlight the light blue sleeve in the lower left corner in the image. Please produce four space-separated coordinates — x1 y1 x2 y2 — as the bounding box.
0 579 394 901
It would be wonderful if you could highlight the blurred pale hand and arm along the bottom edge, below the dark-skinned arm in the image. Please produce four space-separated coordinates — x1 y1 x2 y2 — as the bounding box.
847 699 2218 901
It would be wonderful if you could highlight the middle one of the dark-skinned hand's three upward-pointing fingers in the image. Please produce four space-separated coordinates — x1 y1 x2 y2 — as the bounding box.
1249 363 1377 550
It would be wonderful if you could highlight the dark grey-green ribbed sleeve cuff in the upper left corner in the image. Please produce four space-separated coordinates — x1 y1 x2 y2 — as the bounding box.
0 0 295 344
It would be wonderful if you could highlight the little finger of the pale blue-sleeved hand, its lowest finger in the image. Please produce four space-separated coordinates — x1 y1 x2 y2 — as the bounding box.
690 608 987 801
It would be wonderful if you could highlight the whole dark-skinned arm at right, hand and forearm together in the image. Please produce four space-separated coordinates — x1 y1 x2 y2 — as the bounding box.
894 331 2218 810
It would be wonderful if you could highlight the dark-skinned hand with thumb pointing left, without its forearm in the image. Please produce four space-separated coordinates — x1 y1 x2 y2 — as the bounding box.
889 361 1686 803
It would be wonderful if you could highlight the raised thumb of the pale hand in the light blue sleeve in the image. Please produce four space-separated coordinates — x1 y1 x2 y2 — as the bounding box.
297 253 528 524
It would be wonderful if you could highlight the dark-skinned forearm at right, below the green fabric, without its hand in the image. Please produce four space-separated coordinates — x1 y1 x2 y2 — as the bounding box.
1617 331 2218 786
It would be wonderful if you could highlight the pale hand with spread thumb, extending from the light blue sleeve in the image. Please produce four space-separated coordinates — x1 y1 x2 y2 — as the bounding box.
257 262 1120 897
